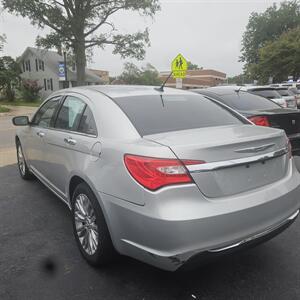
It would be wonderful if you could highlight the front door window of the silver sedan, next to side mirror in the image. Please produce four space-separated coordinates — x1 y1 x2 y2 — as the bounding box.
32 97 60 128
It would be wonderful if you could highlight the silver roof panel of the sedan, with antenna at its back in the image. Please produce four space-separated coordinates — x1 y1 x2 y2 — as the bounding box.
60 85 195 98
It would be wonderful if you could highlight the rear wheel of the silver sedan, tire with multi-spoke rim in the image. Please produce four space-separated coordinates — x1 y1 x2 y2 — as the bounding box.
72 183 116 266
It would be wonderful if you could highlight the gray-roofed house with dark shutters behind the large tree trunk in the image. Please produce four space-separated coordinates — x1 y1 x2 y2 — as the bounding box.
18 47 103 98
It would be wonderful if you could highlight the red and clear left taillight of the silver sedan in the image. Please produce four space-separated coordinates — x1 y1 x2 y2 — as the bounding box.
124 154 205 191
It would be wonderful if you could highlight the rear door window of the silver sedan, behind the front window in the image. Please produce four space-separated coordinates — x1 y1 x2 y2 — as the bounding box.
55 96 86 131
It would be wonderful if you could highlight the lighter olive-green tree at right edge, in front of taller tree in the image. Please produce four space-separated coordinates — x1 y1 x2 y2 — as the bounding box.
252 26 300 83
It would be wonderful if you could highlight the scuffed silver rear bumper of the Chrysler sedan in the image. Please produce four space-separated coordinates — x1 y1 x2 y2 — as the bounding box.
100 159 300 271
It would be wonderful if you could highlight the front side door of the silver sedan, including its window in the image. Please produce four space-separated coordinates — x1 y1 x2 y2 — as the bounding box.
24 96 61 175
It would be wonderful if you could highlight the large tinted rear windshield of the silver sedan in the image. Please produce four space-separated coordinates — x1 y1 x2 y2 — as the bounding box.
114 95 242 136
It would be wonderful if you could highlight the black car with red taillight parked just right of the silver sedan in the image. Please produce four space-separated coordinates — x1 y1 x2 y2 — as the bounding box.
193 86 300 155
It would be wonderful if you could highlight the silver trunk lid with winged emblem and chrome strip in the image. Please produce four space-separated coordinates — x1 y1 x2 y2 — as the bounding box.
144 125 288 198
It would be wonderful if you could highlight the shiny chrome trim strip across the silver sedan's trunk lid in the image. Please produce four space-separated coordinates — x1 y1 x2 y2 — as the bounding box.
186 147 288 173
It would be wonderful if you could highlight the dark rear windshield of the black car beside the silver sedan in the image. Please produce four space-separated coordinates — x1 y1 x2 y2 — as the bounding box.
221 91 279 111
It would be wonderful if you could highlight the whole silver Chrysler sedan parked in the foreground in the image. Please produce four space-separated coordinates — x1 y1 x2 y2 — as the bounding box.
13 86 300 270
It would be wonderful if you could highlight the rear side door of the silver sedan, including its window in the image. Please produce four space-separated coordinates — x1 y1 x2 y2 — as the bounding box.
41 94 93 197
